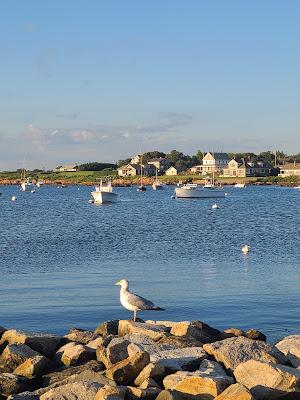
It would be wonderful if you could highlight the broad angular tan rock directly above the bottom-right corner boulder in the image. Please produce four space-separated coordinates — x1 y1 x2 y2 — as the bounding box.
203 336 287 372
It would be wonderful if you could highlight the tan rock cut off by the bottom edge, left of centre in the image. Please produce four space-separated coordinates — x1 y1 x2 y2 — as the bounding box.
40 381 101 400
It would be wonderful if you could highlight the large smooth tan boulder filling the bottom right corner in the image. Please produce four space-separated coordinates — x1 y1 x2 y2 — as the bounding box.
234 360 300 400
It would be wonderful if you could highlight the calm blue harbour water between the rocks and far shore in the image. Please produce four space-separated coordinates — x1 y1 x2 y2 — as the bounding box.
0 186 300 341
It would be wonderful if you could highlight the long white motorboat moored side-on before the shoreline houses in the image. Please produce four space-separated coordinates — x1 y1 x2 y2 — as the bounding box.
175 183 225 199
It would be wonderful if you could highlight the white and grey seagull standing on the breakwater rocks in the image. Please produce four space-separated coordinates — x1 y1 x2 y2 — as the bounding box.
116 279 164 322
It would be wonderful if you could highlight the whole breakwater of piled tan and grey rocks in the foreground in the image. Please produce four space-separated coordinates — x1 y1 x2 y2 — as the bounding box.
0 320 300 400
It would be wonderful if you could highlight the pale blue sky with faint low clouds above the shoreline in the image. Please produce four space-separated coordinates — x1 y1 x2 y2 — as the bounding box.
0 0 300 170
